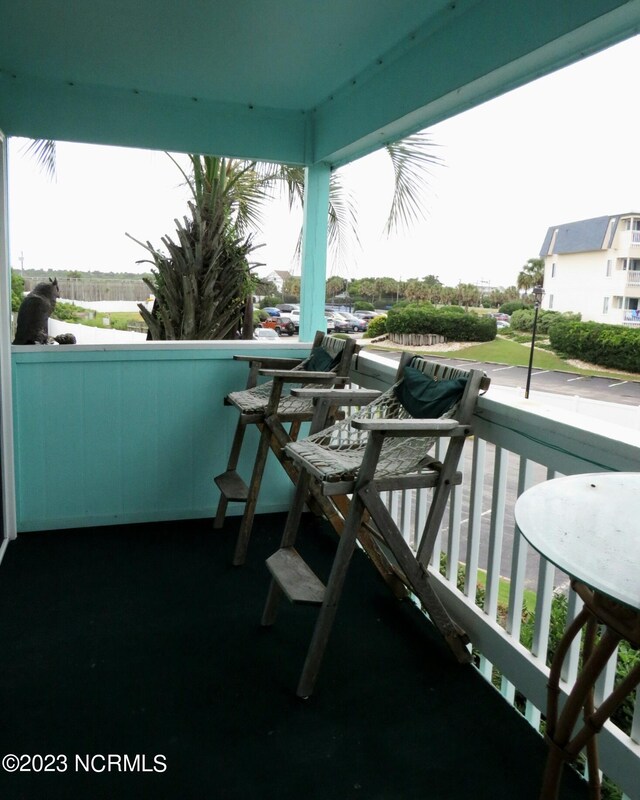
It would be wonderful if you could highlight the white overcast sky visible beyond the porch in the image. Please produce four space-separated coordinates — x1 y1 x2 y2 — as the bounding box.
9 37 640 286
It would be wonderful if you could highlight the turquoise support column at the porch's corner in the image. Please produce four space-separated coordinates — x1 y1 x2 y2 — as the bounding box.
300 162 331 342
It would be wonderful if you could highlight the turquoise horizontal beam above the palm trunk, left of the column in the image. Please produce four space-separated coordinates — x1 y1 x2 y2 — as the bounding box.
0 76 309 164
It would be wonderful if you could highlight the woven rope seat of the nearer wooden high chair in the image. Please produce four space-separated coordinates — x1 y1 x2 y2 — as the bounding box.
285 384 458 482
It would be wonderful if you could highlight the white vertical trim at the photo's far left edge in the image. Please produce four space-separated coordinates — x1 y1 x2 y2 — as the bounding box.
0 132 17 540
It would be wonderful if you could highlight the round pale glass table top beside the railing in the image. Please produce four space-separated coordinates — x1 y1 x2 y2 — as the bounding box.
515 472 640 609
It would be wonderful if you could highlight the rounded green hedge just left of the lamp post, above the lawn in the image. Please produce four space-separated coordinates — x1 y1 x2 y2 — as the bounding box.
387 304 497 342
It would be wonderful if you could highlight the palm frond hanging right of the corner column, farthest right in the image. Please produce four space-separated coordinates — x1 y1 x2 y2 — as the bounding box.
385 131 443 235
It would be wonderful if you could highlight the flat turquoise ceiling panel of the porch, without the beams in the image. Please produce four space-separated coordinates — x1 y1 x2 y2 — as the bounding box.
0 0 438 110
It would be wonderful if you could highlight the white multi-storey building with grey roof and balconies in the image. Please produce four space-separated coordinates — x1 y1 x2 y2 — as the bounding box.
540 212 640 326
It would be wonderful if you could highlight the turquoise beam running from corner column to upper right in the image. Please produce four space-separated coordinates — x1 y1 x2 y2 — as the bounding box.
313 0 640 166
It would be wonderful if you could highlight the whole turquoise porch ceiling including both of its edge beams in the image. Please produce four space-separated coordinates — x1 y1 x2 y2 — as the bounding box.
0 0 640 164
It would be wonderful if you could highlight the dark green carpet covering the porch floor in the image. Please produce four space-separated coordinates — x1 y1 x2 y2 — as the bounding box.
0 515 586 800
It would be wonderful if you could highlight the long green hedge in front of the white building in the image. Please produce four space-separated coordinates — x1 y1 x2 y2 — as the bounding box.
549 318 640 372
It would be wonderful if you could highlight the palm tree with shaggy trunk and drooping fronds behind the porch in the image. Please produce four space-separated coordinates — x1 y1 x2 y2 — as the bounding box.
27 132 441 339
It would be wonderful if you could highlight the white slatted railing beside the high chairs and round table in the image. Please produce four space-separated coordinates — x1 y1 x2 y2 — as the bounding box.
354 357 640 800
